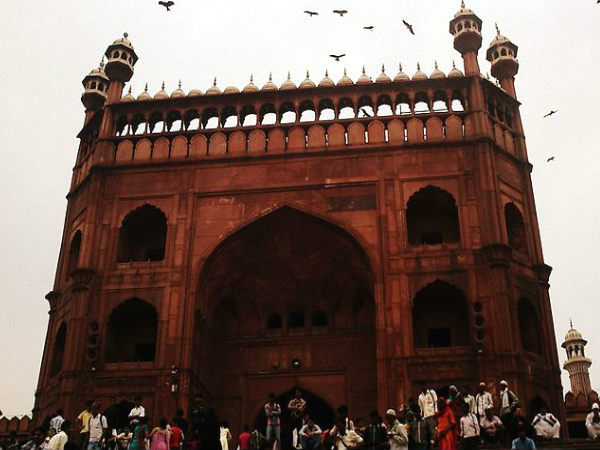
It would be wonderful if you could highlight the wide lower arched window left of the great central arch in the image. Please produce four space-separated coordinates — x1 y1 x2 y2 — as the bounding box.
106 298 158 362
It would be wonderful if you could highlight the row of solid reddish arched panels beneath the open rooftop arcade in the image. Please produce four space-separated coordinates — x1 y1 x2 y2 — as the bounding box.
115 115 471 162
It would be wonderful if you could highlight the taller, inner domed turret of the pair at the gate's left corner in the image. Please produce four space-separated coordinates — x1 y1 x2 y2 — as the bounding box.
105 33 138 104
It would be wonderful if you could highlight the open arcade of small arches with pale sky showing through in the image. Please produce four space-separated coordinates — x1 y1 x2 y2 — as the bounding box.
115 90 466 136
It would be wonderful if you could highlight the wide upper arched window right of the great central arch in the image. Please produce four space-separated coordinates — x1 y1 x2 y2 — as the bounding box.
406 185 460 245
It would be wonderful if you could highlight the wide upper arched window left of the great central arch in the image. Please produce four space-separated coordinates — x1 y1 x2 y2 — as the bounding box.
117 205 167 262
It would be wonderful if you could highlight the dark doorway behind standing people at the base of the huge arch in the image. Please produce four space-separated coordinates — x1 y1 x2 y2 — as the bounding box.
254 388 335 449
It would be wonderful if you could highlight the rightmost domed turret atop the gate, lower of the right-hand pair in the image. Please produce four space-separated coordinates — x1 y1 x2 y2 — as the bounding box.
486 24 519 98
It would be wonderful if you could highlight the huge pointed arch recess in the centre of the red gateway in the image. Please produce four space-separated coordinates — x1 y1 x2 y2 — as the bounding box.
192 207 377 429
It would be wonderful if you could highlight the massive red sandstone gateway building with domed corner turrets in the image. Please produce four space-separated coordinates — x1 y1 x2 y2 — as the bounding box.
34 2 564 429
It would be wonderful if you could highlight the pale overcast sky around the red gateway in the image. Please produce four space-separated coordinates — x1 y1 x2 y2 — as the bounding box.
0 0 600 415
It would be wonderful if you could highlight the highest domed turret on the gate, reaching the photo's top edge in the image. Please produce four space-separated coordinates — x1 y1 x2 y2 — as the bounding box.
450 1 483 76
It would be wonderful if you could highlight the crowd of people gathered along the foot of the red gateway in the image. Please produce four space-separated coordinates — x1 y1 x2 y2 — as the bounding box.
7 381 600 450
